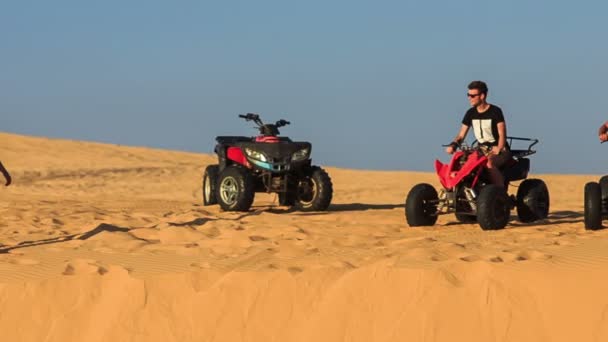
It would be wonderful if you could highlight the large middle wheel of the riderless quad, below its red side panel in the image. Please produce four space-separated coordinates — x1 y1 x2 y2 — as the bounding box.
216 166 255 211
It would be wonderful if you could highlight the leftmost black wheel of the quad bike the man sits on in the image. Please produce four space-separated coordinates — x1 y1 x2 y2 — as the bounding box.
405 183 439 227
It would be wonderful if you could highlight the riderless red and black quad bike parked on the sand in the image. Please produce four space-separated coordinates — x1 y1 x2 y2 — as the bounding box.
203 113 333 211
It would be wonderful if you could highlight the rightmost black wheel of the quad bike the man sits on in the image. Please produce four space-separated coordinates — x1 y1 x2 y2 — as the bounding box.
516 179 549 222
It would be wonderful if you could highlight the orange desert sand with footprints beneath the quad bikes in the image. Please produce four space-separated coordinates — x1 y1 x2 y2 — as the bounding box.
0 133 608 342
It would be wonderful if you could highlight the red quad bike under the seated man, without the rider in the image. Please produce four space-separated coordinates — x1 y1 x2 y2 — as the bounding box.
405 137 549 230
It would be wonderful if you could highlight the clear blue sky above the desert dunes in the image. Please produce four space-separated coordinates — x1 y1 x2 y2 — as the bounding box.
0 0 608 173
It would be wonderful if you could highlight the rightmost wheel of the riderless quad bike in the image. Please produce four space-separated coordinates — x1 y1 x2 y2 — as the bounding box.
294 166 333 211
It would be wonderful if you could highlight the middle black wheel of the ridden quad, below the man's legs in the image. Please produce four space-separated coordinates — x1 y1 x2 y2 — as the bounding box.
477 184 511 230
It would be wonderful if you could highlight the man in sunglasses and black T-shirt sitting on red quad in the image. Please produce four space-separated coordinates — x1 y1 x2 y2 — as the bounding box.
446 81 511 186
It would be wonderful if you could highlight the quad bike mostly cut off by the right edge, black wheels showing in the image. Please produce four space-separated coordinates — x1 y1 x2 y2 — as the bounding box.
585 176 608 230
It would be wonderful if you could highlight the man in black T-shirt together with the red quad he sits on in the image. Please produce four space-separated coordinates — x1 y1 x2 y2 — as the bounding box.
405 81 549 230
